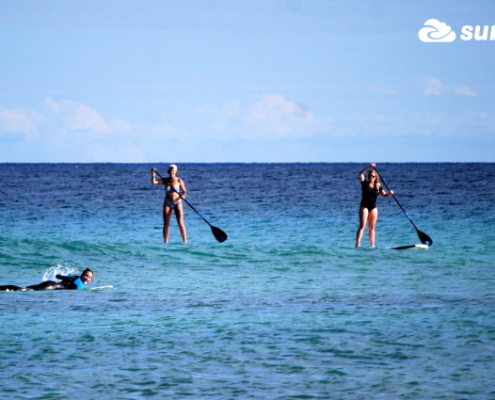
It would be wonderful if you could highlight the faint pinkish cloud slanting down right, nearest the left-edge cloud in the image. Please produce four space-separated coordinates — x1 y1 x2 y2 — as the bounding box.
45 98 111 135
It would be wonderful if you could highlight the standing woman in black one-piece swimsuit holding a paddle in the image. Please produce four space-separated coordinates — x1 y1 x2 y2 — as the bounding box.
356 163 394 247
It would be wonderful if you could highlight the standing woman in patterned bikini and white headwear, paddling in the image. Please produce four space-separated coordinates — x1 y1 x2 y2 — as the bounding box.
151 164 187 243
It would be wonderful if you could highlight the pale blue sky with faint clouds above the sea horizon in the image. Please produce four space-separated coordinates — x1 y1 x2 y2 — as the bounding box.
0 0 495 163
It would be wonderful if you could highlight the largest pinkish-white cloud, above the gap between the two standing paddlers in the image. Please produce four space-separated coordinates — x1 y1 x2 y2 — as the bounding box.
214 94 327 139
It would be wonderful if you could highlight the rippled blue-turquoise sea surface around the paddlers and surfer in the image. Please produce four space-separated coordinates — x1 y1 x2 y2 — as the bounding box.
0 160 495 400
